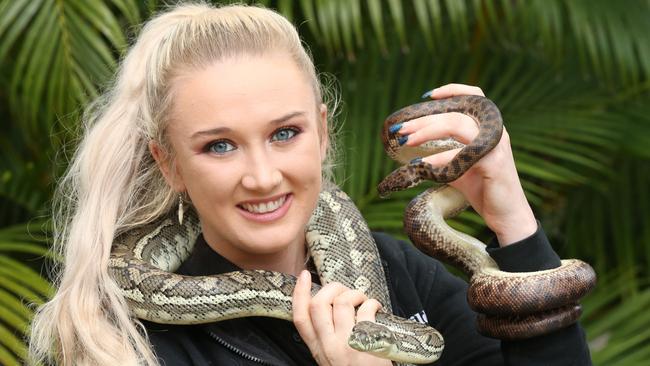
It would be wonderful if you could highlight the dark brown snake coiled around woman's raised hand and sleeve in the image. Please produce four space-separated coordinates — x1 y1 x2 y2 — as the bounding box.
378 96 596 339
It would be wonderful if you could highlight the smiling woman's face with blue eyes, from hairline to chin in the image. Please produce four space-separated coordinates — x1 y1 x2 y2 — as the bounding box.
154 53 327 268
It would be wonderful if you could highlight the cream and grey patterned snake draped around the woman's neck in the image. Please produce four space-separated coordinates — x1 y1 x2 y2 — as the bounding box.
108 185 444 363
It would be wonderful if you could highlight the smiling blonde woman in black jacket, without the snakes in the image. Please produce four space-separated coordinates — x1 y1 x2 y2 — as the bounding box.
30 4 589 366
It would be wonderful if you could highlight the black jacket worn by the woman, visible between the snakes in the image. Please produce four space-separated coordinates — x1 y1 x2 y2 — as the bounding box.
143 229 591 366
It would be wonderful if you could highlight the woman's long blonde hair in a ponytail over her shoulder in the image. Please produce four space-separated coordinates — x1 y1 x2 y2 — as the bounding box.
29 4 335 365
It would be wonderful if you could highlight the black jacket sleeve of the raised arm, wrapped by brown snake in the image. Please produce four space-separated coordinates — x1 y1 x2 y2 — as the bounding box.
378 225 591 366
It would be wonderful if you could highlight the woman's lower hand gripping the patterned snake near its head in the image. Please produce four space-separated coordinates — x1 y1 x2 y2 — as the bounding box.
293 271 392 366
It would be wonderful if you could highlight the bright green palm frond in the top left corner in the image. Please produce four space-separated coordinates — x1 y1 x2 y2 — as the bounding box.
0 0 139 140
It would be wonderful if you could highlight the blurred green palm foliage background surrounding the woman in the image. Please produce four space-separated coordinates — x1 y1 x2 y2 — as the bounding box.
0 0 650 365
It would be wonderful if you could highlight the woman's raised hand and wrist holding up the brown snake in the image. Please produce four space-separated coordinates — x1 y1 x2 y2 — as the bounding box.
398 84 537 246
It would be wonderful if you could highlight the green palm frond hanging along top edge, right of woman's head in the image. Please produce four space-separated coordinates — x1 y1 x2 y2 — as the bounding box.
288 0 650 84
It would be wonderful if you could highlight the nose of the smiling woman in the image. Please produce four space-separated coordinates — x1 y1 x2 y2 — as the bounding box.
241 151 282 192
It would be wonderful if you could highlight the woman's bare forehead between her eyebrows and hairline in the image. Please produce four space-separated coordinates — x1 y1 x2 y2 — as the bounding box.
171 54 316 134
